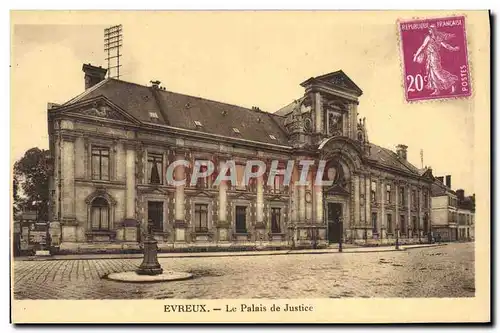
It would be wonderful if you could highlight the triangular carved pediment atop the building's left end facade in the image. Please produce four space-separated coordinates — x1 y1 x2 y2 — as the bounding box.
58 96 139 124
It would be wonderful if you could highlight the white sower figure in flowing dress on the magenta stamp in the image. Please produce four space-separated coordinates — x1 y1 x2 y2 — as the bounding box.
413 25 460 95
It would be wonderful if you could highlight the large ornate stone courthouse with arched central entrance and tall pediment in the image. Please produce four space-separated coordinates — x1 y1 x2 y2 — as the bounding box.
48 65 434 251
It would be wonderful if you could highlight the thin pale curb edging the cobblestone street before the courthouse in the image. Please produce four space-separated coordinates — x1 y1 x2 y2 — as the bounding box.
14 243 448 261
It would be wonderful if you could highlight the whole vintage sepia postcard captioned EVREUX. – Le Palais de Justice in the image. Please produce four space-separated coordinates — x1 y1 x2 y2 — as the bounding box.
10 11 491 323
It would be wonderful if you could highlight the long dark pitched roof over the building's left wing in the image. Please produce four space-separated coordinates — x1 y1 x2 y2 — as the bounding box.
64 79 288 145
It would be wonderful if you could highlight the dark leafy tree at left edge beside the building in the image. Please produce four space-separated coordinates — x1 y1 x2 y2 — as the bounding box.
13 147 51 221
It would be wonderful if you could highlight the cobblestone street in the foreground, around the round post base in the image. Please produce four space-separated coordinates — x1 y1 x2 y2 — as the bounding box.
10 243 475 299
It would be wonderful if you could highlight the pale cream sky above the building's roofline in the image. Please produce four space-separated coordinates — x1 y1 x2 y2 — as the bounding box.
11 12 475 194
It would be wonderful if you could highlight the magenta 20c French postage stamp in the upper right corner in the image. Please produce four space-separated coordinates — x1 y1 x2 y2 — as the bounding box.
398 16 471 101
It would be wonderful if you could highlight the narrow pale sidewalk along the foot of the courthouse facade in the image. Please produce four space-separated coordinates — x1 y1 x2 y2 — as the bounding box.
14 243 446 261
